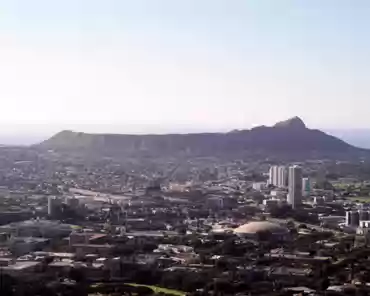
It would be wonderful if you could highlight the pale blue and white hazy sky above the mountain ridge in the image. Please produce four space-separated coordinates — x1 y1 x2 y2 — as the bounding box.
0 0 370 140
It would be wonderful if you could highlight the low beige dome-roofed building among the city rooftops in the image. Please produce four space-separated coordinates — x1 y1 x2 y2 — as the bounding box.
234 221 290 241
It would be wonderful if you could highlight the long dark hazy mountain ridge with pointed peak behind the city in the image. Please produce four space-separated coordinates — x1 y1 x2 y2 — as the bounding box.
37 117 370 159
